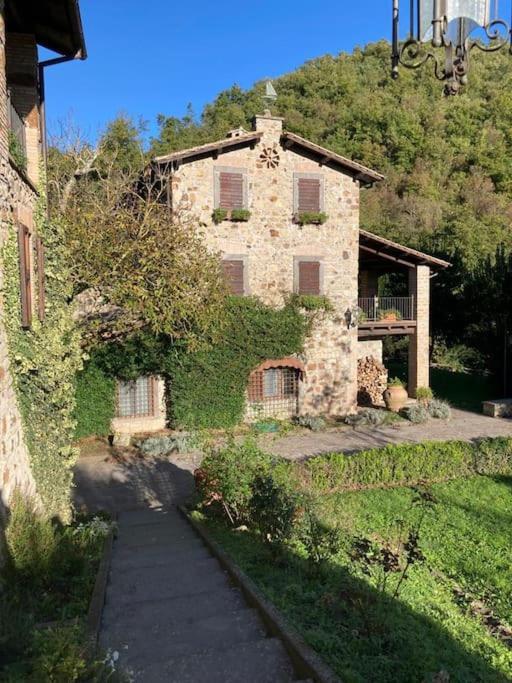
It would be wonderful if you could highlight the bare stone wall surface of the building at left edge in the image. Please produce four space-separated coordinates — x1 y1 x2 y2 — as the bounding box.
0 3 36 509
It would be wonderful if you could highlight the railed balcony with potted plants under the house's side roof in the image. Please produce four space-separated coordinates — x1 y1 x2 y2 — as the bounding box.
358 296 416 338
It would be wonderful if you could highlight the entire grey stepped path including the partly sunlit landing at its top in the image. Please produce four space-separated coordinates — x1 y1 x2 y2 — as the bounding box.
75 448 304 683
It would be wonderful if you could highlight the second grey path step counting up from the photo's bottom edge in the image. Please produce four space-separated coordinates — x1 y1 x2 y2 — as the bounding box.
102 607 266 669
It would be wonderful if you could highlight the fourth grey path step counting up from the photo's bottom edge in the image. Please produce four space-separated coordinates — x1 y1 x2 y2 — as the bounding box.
106 558 230 605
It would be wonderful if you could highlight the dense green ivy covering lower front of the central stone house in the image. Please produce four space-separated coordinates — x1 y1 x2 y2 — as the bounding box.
77 297 316 435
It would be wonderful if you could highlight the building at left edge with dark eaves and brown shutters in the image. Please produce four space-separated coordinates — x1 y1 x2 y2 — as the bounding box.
0 0 86 512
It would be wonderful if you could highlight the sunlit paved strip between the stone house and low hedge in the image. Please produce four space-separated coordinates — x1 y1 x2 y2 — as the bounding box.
265 410 512 460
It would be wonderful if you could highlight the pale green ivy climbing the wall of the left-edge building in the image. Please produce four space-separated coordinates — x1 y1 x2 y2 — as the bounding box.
2 179 82 518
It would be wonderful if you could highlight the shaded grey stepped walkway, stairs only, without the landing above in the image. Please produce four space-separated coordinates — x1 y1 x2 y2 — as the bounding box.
100 509 296 683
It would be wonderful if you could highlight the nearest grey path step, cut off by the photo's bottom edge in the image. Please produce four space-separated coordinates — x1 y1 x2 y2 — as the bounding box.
127 638 296 683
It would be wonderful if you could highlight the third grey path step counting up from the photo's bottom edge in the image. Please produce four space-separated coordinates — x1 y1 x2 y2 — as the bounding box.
102 586 247 629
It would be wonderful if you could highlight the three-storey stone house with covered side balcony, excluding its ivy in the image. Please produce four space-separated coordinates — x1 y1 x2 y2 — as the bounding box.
113 113 448 433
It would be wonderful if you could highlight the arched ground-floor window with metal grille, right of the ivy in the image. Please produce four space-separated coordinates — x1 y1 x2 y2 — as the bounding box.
248 367 301 418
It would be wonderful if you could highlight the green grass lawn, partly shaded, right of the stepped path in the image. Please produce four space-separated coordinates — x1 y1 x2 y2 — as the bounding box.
200 477 512 683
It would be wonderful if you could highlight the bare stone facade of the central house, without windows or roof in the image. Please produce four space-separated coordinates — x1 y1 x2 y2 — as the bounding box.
172 116 360 415
